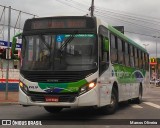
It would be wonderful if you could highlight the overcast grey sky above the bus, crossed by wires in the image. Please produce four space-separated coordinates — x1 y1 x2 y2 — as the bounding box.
0 0 160 57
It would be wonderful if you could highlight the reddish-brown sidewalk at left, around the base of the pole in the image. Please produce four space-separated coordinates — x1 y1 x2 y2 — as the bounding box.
0 91 18 105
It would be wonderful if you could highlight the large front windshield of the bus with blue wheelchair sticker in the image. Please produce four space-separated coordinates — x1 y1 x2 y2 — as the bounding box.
21 34 98 71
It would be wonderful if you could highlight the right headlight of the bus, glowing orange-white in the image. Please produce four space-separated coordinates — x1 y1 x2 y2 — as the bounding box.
79 81 96 95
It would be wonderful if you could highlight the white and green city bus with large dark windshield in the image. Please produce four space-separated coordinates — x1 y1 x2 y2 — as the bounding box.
19 16 149 114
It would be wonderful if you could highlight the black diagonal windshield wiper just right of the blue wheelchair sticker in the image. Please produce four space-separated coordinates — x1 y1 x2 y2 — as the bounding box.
59 31 78 54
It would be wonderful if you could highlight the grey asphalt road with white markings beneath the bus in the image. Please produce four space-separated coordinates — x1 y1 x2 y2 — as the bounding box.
0 84 160 128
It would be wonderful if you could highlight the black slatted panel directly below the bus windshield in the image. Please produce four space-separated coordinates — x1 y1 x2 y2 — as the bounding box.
21 71 95 83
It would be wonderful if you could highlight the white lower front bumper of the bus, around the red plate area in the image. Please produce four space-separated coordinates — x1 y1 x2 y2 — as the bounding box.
19 89 99 107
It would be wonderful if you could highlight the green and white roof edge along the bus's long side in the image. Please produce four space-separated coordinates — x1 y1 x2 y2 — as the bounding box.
108 25 148 53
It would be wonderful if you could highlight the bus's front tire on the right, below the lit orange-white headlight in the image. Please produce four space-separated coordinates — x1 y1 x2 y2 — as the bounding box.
102 88 118 114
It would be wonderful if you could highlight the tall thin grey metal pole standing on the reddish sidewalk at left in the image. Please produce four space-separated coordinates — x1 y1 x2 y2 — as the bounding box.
5 6 11 100
